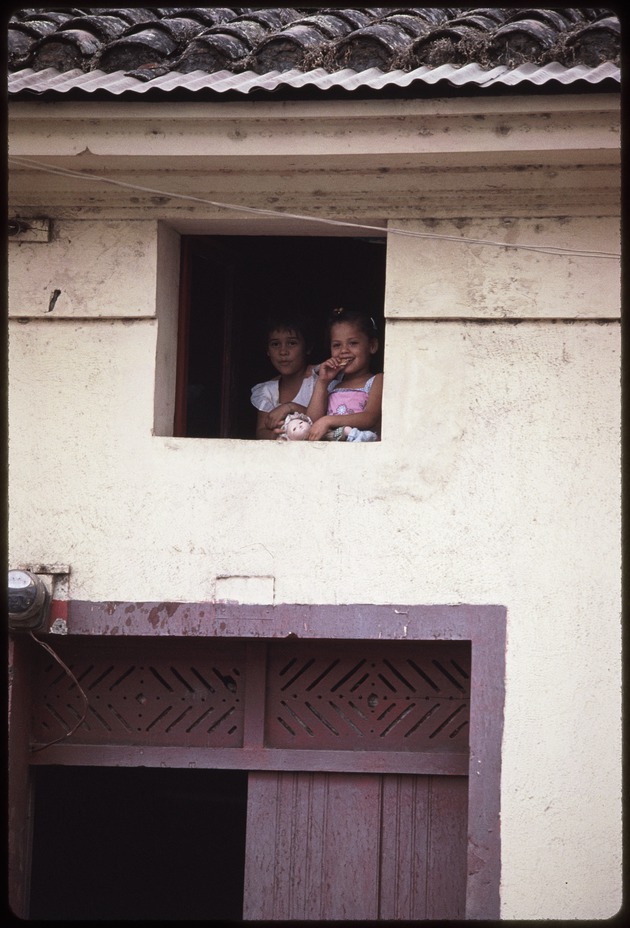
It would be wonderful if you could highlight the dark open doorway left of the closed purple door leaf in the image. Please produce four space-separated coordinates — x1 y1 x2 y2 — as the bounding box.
30 766 247 921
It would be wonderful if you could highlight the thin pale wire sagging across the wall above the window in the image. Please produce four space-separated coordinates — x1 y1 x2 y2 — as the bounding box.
8 158 621 260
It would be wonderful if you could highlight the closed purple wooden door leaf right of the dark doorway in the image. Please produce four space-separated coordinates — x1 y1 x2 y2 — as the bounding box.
243 772 467 920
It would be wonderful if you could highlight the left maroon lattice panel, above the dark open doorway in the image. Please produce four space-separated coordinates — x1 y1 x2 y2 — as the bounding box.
32 638 245 747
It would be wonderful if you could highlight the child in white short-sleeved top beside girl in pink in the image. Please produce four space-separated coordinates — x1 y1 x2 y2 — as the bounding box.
251 314 317 439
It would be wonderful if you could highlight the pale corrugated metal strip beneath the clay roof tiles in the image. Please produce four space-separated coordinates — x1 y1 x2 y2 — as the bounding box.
9 62 620 96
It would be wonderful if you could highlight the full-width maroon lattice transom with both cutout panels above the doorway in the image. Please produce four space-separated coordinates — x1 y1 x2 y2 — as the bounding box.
32 637 470 755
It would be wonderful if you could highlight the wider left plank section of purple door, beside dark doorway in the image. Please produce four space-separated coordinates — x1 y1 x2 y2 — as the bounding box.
243 773 380 921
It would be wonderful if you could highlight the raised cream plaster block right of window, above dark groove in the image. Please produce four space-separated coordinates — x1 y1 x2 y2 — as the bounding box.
387 216 620 319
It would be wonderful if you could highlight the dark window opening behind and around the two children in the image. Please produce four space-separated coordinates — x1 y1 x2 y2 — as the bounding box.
174 235 386 439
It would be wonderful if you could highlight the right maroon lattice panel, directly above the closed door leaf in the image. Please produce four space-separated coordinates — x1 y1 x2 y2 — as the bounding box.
265 641 470 752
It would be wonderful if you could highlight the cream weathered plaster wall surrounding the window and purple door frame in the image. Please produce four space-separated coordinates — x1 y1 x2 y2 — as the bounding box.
9 220 621 919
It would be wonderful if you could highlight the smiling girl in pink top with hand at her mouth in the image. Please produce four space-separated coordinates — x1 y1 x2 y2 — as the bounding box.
306 309 383 441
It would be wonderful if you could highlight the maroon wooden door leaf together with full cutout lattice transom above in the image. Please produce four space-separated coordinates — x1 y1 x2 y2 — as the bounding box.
31 636 474 921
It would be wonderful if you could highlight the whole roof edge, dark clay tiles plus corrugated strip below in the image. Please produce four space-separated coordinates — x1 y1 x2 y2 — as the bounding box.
8 7 621 99
